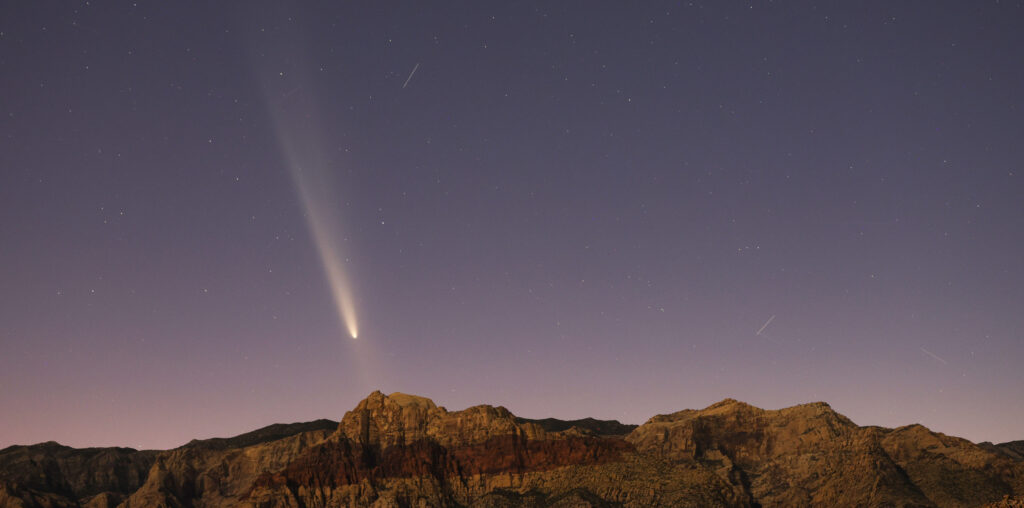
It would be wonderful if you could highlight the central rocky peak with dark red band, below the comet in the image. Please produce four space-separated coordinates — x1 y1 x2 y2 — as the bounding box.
249 392 632 506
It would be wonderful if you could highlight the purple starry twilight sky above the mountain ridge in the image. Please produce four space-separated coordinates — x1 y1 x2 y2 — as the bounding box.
0 1 1024 448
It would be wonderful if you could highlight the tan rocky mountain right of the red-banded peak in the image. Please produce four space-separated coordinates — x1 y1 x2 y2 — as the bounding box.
627 399 1024 506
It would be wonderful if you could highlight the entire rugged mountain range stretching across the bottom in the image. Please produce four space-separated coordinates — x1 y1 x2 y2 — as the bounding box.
0 392 1024 508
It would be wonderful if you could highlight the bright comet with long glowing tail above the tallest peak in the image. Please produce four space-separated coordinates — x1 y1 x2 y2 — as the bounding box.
251 12 374 388
